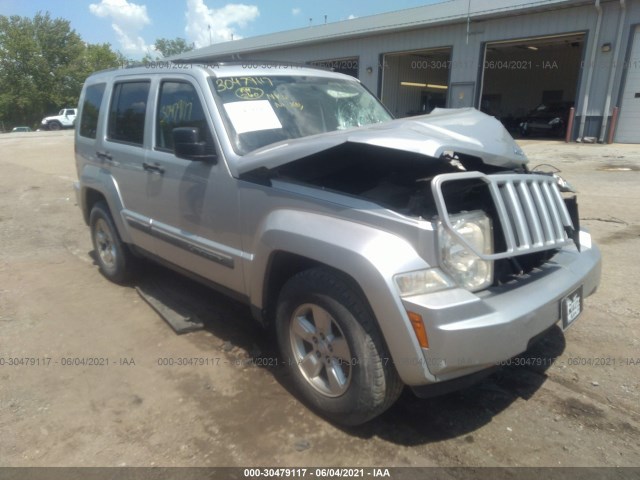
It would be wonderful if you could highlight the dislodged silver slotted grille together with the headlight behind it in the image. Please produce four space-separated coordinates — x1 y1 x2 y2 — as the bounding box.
431 172 580 291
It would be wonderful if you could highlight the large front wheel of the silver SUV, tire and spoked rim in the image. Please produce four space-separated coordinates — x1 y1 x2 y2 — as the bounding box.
275 268 403 426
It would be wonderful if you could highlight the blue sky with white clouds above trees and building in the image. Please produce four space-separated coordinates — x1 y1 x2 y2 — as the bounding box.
0 0 441 59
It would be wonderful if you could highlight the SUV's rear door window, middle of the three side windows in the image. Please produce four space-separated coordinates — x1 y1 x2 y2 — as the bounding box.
107 81 150 145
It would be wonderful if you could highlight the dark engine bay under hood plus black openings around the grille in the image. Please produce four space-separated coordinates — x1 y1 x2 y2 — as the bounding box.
269 142 577 284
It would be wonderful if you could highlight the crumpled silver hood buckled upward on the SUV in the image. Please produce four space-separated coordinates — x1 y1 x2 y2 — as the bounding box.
236 108 528 174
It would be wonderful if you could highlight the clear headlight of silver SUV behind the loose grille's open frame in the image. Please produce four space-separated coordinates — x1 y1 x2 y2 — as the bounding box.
438 210 493 292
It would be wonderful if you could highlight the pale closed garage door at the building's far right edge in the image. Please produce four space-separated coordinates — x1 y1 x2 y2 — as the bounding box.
616 27 640 143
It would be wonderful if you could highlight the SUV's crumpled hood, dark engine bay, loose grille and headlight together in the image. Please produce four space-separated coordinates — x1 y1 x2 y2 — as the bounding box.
241 109 579 291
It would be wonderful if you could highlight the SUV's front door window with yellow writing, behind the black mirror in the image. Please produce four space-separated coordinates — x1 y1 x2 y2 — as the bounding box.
155 81 215 153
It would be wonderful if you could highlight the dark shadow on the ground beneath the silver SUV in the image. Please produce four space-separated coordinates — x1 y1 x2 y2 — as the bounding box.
92 252 565 446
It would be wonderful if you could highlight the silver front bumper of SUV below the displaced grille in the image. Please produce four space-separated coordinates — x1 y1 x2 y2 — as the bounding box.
396 232 601 386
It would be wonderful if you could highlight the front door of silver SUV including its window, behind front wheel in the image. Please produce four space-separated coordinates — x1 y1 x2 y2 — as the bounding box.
145 76 243 290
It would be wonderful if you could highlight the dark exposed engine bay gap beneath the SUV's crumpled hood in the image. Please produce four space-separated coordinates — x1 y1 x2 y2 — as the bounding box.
272 143 524 220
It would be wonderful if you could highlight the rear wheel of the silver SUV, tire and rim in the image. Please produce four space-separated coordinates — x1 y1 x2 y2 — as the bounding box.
89 201 135 284
